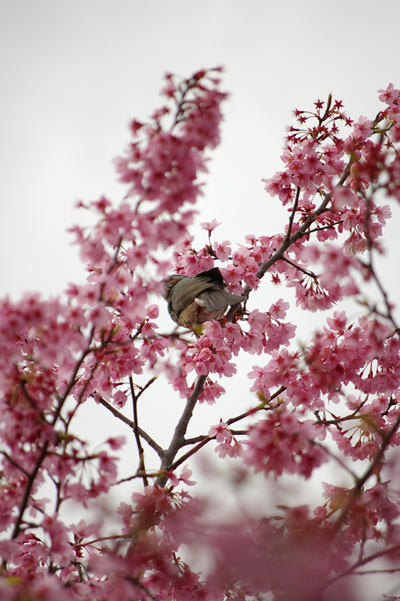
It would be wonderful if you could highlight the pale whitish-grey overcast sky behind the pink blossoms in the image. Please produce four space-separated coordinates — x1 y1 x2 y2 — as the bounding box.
0 0 400 596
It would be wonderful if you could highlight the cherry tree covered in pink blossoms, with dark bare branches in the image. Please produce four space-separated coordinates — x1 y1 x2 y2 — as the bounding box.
0 69 400 601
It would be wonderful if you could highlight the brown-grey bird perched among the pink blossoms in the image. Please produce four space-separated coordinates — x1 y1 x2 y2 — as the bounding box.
164 267 246 328
